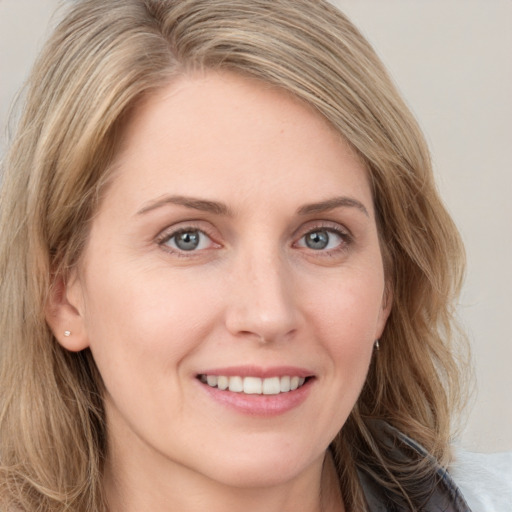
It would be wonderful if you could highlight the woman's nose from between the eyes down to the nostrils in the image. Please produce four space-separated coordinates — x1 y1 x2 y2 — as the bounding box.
225 247 299 343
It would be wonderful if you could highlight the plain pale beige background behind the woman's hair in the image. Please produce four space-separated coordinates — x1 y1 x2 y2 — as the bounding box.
0 0 512 451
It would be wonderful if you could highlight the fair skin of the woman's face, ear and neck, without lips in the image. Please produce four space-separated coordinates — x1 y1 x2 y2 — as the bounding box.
48 72 390 512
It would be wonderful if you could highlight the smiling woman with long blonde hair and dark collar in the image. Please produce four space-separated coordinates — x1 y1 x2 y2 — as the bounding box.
0 0 468 512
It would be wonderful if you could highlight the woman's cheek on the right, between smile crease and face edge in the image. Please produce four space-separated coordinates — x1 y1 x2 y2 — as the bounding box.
294 267 383 440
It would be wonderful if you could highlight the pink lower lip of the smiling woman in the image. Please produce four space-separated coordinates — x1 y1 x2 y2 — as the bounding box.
197 378 315 417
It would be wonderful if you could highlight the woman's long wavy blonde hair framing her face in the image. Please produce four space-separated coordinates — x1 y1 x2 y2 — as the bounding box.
0 0 464 512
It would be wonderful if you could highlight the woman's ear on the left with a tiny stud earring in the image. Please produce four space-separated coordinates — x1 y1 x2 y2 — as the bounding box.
45 274 89 352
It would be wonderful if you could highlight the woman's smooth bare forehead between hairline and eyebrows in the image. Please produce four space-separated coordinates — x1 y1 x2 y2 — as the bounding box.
107 72 371 215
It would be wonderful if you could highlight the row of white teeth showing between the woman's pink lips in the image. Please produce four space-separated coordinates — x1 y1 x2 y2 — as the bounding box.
198 374 310 395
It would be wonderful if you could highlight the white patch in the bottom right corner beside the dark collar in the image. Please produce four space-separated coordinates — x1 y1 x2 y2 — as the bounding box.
448 448 512 512
